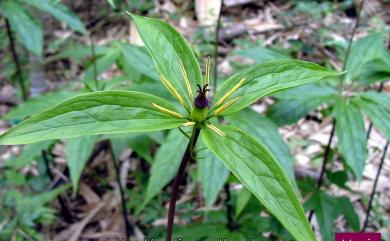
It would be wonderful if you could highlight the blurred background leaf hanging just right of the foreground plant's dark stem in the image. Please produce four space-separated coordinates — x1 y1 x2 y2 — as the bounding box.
197 145 230 207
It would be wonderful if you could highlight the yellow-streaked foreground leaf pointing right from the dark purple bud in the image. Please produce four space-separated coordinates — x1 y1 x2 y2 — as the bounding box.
214 60 340 115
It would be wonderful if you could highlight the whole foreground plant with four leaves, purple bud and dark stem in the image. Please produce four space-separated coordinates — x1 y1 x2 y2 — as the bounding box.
0 15 340 240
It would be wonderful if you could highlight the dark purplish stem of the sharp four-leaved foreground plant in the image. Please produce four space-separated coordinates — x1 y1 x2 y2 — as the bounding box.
166 127 200 241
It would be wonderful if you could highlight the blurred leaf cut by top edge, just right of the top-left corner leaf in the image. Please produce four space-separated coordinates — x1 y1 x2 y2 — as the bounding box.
23 0 87 34
